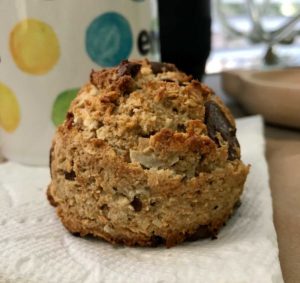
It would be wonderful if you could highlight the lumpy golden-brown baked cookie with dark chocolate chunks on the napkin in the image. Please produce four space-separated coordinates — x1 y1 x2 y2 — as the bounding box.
47 60 249 247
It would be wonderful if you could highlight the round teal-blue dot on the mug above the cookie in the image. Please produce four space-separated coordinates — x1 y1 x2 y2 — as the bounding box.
85 12 133 67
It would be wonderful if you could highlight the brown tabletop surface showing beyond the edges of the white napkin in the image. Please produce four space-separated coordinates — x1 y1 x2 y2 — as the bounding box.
0 75 300 283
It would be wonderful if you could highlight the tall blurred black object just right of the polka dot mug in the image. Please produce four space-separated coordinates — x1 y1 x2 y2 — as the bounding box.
158 0 211 79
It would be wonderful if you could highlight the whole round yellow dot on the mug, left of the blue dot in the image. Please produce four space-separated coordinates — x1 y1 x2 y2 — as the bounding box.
10 19 60 75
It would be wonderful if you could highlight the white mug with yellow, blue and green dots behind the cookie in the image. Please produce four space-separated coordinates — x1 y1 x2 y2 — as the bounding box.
0 0 159 165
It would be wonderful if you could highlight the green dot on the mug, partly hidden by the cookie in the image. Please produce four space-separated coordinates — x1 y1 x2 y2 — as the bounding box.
51 88 79 127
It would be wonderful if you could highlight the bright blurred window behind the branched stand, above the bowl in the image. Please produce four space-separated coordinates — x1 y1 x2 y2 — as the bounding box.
206 0 300 73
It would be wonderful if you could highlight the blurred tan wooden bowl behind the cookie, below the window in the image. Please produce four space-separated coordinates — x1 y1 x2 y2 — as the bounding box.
222 68 300 129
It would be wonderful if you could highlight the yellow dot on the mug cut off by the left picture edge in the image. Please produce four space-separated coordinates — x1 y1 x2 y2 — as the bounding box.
0 83 20 133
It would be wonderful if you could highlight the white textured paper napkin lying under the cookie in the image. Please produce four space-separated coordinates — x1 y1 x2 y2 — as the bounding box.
0 116 283 283
